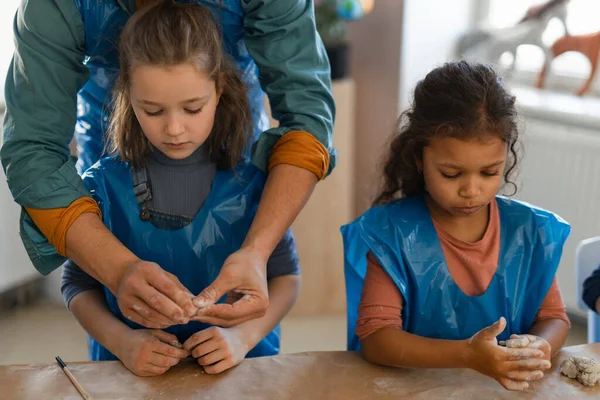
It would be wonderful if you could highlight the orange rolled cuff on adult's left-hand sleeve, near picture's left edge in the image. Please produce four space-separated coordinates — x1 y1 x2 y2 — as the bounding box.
25 197 102 257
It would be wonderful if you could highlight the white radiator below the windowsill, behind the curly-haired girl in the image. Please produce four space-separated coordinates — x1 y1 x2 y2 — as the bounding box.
515 115 600 316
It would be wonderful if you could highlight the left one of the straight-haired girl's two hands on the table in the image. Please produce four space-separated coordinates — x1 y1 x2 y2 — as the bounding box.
116 329 189 376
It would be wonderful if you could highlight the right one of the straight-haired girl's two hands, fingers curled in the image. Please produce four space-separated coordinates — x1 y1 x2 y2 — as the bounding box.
183 326 249 374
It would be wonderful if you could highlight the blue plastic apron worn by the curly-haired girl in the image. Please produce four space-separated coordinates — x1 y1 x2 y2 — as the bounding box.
342 196 570 350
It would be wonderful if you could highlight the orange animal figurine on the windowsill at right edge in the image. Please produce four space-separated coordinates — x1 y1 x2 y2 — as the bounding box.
536 32 600 96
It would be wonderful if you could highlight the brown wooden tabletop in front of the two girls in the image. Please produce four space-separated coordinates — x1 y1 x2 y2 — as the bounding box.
0 344 600 400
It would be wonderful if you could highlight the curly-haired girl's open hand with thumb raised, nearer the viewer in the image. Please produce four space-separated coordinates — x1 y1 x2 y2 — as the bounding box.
467 317 550 390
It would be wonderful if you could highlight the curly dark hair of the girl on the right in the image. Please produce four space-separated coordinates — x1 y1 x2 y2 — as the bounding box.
373 60 519 205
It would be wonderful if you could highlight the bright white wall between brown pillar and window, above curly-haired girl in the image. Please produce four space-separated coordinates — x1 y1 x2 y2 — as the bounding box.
399 0 477 111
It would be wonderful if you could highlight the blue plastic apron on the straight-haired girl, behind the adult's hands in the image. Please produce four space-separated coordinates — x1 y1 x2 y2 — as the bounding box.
83 157 279 360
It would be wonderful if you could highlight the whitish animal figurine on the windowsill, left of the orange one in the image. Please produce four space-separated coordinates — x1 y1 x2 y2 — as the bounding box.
455 0 569 75
